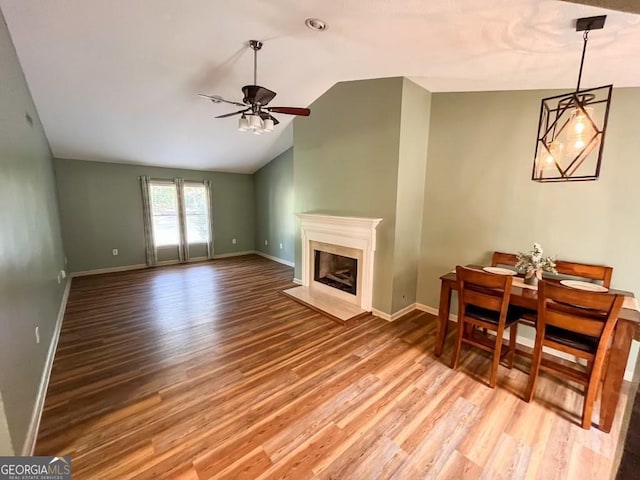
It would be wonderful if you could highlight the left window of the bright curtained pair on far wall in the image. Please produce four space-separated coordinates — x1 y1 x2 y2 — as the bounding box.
150 182 180 247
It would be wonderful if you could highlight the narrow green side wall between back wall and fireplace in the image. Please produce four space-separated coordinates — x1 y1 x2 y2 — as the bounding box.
253 148 295 263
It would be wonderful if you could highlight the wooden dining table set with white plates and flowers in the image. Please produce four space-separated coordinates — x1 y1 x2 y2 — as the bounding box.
435 265 640 433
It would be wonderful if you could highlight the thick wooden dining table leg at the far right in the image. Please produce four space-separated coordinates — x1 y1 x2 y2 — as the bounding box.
598 320 634 433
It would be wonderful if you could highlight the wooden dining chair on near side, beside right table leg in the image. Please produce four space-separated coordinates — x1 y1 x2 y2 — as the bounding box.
525 280 624 429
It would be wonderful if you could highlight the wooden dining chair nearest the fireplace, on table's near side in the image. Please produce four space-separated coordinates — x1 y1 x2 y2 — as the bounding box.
451 266 520 388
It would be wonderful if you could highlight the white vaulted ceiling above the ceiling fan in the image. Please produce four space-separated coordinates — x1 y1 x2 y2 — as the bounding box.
0 0 640 172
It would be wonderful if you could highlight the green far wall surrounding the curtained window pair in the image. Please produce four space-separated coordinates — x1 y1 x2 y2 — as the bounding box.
55 159 255 272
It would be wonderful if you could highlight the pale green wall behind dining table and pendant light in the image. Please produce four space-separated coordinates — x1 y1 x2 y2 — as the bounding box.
418 88 640 376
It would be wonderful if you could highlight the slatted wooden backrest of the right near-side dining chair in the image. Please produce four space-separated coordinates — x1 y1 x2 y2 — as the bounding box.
537 280 624 342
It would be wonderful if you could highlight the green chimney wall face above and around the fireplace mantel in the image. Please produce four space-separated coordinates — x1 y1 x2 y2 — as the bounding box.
293 78 403 312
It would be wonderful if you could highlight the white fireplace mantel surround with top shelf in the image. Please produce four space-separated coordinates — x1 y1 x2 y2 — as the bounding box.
297 213 382 311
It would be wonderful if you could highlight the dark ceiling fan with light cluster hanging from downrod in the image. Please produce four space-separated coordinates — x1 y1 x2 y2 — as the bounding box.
198 40 311 135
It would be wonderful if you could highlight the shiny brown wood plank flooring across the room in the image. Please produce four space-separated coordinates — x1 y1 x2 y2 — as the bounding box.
36 255 626 480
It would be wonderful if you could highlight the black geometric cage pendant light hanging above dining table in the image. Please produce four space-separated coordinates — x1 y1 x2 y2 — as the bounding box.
531 15 613 182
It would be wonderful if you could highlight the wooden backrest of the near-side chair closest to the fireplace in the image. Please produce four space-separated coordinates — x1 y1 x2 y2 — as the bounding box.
456 265 513 320
